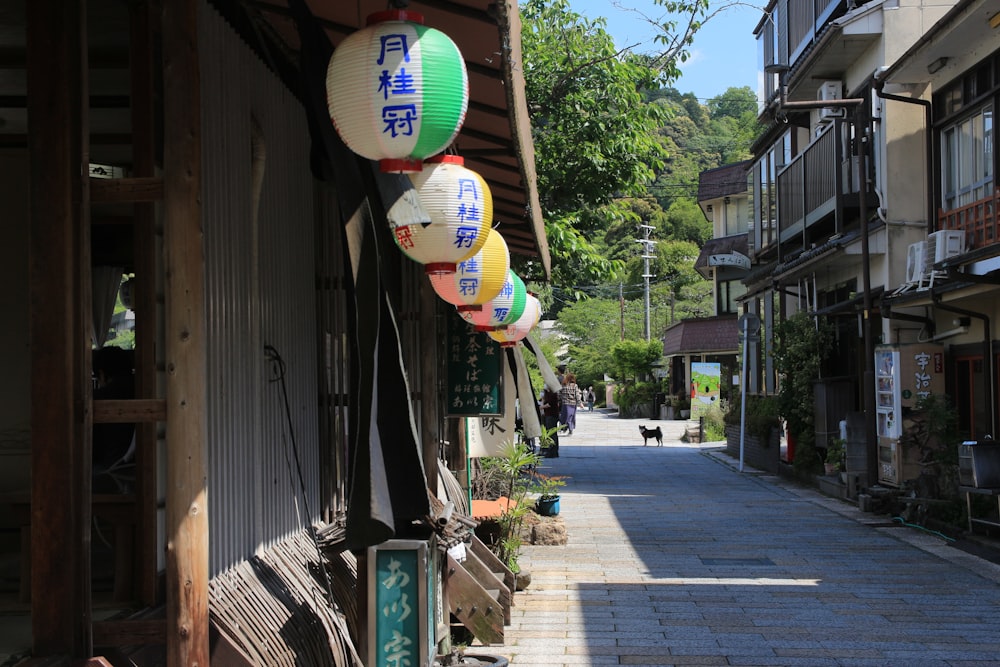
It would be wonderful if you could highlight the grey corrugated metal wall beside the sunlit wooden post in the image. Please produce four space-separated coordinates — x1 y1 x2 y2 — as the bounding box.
199 5 321 575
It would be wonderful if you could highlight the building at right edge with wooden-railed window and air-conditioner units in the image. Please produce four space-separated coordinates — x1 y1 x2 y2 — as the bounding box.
876 0 1000 452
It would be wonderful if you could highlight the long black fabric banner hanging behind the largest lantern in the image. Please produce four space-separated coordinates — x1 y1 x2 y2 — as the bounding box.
289 0 430 550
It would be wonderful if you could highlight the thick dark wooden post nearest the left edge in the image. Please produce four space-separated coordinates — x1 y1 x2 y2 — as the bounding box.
24 0 92 657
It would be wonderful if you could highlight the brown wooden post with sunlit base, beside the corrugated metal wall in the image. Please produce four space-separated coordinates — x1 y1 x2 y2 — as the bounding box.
163 0 209 667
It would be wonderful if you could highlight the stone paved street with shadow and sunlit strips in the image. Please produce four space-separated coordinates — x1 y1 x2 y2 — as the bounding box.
484 412 1000 667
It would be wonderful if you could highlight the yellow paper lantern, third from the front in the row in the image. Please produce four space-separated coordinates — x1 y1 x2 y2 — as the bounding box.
429 229 510 308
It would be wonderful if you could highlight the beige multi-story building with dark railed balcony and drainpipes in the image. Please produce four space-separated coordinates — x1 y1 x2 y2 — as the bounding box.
742 0 955 482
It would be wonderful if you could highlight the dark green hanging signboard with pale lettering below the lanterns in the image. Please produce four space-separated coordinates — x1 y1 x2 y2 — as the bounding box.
446 317 504 417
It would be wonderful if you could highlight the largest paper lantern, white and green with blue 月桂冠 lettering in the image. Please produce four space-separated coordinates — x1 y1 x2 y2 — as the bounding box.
326 10 469 172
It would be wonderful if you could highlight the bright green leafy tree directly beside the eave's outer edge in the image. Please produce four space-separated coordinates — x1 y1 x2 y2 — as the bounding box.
521 0 666 284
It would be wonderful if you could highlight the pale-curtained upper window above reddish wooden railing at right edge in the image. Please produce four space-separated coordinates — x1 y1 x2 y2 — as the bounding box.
941 104 994 211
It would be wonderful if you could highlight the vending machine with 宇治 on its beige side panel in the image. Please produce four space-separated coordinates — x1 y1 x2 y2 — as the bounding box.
875 343 944 486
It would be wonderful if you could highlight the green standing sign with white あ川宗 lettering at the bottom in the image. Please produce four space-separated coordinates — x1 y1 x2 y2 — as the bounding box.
367 540 435 667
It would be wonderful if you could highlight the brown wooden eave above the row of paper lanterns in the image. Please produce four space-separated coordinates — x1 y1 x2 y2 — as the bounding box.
220 0 551 279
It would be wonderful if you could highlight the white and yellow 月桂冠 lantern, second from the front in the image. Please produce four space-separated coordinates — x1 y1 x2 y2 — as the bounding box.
392 155 493 274
